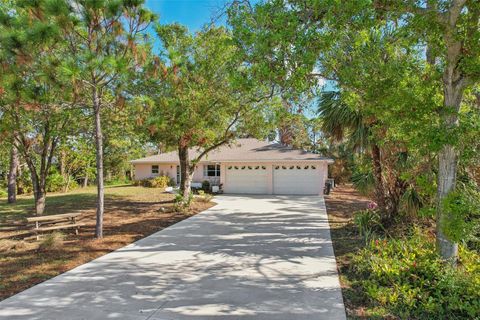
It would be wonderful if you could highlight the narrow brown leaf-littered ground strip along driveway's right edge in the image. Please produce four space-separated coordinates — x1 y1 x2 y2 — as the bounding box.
325 185 375 319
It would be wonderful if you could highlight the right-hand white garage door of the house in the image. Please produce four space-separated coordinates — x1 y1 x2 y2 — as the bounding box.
273 165 323 195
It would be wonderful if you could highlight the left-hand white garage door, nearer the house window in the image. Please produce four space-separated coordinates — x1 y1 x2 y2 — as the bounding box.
224 165 268 194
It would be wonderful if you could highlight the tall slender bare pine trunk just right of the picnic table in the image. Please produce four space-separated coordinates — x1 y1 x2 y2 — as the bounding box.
92 88 105 239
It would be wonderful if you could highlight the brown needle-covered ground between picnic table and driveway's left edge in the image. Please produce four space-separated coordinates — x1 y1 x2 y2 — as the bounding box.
0 200 213 300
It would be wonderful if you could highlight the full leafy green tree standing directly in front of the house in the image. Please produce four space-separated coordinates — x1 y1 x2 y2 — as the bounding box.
142 24 276 198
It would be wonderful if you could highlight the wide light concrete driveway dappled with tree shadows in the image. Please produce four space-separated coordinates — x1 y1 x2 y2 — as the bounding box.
0 196 345 320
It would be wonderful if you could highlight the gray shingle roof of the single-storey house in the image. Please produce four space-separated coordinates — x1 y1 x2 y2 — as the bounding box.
131 139 333 164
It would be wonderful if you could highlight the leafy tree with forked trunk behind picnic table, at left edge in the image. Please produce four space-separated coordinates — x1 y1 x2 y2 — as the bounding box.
0 1 80 214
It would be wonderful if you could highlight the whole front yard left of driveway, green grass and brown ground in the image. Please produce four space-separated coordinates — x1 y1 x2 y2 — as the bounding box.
0 185 214 300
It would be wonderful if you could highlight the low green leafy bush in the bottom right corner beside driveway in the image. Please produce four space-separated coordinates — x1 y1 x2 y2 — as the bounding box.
350 230 480 319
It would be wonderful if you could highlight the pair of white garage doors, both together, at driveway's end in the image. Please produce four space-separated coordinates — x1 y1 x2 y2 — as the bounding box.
223 162 327 195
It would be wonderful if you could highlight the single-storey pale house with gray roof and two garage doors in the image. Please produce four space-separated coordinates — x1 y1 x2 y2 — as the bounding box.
131 139 333 195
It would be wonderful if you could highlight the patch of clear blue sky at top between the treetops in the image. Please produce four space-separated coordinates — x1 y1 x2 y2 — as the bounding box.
146 0 226 32
